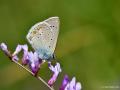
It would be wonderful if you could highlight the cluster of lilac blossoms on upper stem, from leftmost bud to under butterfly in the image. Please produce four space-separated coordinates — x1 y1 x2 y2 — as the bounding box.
0 43 42 75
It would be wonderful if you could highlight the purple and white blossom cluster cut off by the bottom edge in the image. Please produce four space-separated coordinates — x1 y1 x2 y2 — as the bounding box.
60 75 82 90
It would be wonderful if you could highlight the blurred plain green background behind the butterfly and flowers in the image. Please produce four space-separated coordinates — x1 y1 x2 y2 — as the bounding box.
0 0 120 90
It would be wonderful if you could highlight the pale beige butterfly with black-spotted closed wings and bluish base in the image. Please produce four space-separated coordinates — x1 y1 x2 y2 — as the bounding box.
26 17 60 61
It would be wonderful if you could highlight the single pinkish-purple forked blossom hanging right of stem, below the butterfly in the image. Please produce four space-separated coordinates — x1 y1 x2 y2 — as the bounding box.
48 63 62 86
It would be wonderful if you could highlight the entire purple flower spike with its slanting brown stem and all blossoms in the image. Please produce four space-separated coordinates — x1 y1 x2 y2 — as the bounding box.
0 43 82 90
